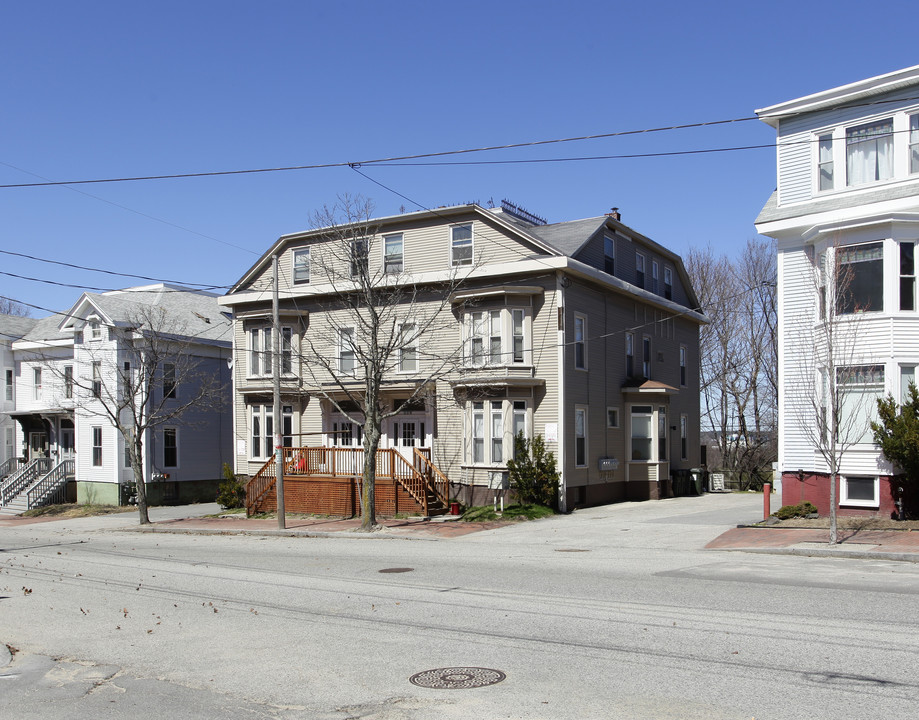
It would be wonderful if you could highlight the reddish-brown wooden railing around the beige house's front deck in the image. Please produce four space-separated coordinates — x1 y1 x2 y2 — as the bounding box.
246 447 448 515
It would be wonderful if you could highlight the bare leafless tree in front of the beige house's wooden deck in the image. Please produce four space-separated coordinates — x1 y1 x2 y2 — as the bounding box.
303 196 474 531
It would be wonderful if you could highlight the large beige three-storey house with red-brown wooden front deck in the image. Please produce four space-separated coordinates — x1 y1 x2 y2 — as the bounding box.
220 202 706 512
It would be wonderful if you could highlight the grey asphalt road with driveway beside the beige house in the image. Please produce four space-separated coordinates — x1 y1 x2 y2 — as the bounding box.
0 495 919 720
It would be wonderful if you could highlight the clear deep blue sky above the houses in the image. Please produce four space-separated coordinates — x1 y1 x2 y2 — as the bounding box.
0 0 919 316
